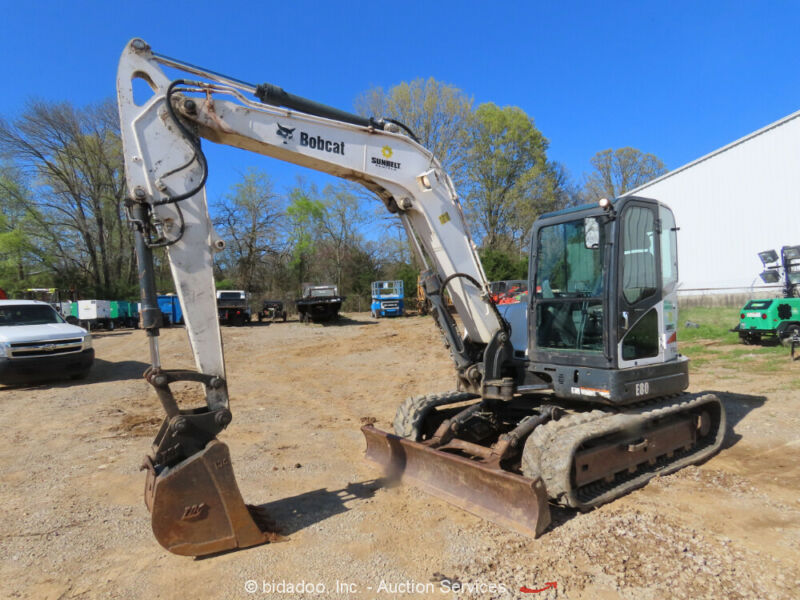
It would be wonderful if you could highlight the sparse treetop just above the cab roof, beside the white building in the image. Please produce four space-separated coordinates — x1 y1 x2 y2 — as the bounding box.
583 147 666 202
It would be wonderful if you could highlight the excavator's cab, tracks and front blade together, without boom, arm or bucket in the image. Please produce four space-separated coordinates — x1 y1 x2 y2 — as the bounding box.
362 197 725 537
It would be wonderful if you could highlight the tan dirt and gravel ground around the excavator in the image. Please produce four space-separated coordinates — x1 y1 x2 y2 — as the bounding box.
0 314 800 600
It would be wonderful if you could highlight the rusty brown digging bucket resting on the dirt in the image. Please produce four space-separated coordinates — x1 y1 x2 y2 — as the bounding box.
144 439 281 556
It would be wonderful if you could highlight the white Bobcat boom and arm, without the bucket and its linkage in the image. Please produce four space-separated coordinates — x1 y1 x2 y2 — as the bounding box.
117 39 506 384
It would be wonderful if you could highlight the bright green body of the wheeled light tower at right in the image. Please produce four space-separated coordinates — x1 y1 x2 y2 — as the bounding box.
731 298 800 344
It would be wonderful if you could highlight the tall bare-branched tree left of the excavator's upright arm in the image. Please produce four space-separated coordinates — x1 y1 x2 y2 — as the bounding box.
0 100 136 297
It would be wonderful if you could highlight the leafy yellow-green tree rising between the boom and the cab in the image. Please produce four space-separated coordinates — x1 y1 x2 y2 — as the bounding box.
464 103 557 250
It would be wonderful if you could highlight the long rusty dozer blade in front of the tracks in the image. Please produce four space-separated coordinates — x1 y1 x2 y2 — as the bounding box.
361 425 550 537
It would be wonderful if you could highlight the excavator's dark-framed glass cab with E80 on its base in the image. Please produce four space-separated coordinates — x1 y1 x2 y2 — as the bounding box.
527 198 689 404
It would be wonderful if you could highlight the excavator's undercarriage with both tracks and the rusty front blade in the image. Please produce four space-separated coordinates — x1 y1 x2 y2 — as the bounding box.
362 392 725 537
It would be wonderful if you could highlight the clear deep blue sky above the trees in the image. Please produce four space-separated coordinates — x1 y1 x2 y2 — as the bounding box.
0 0 800 206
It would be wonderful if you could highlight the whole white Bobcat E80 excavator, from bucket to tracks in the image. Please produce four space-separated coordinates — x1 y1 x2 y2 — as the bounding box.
117 39 726 556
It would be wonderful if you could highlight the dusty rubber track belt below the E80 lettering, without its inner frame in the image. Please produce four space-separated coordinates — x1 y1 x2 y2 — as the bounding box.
522 394 726 510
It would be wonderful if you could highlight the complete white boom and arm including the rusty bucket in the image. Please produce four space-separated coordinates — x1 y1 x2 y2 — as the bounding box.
117 39 514 555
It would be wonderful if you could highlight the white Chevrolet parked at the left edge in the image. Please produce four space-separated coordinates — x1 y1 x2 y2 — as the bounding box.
0 300 94 383
